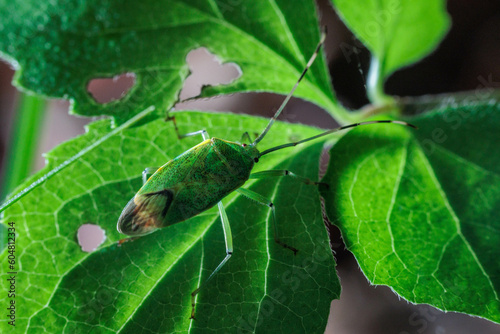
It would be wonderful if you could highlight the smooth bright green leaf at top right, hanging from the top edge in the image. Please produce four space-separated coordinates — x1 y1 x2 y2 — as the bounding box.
332 0 450 77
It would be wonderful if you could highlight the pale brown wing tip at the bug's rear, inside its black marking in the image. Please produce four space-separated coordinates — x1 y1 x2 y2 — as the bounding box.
116 196 158 237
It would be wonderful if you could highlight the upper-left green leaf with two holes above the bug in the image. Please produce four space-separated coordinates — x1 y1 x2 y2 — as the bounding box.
0 0 340 123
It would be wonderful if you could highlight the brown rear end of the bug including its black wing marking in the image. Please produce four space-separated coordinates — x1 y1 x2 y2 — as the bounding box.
117 189 174 236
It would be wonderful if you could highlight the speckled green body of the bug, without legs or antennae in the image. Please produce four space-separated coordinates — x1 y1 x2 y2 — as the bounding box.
119 138 258 235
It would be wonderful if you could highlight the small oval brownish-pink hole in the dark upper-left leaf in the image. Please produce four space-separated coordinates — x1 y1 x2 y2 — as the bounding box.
87 73 135 103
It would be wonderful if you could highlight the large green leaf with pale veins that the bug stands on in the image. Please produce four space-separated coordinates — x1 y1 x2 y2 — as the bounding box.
0 112 340 333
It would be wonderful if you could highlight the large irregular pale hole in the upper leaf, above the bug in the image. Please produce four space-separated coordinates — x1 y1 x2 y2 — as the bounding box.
180 48 242 101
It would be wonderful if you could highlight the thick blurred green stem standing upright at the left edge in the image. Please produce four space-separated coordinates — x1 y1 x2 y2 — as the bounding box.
1 93 45 198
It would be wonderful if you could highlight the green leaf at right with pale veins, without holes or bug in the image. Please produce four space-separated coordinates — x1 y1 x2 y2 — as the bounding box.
322 102 500 322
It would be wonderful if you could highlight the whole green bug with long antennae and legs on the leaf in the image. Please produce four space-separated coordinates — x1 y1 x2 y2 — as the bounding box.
117 33 413 319
